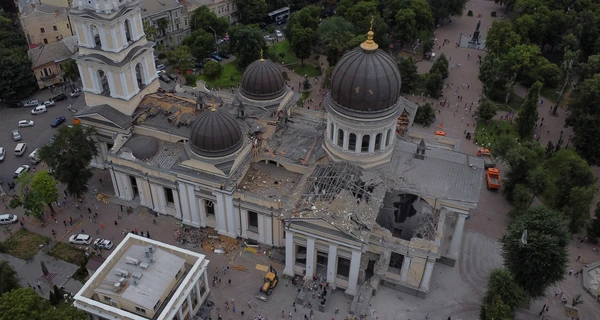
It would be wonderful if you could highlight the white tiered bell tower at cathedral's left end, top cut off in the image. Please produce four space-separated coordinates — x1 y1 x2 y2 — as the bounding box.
69 0 160 116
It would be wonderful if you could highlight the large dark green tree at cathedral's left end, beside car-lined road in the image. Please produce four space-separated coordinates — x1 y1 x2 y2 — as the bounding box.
40 125 98 196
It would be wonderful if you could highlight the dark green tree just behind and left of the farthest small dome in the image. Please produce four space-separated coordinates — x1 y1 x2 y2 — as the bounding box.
229 24 267 68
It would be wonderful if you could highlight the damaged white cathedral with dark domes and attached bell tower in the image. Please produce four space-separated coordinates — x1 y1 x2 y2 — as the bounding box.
70 0 484 297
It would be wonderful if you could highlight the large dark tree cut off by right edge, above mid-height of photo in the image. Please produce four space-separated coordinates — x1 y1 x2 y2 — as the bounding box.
566 74 600 166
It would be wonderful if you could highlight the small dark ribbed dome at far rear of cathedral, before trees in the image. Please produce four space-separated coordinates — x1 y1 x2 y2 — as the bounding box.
240 59 285 100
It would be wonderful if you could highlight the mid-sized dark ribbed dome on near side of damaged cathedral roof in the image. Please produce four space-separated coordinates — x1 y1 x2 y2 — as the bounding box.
190 108 243 157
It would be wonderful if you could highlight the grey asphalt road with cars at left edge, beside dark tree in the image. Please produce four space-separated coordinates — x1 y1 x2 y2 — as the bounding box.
0 94 75 185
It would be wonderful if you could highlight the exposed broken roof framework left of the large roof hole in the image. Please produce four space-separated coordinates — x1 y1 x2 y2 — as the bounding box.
302 162 373 202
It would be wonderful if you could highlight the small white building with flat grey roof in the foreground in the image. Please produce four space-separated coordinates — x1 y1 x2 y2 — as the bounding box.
75 234 210 320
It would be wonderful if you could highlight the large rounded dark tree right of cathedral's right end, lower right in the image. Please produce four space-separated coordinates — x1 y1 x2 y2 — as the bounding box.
501 206 569 299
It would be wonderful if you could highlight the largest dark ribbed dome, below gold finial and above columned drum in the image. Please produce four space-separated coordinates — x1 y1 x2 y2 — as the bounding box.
330 48 400 117
